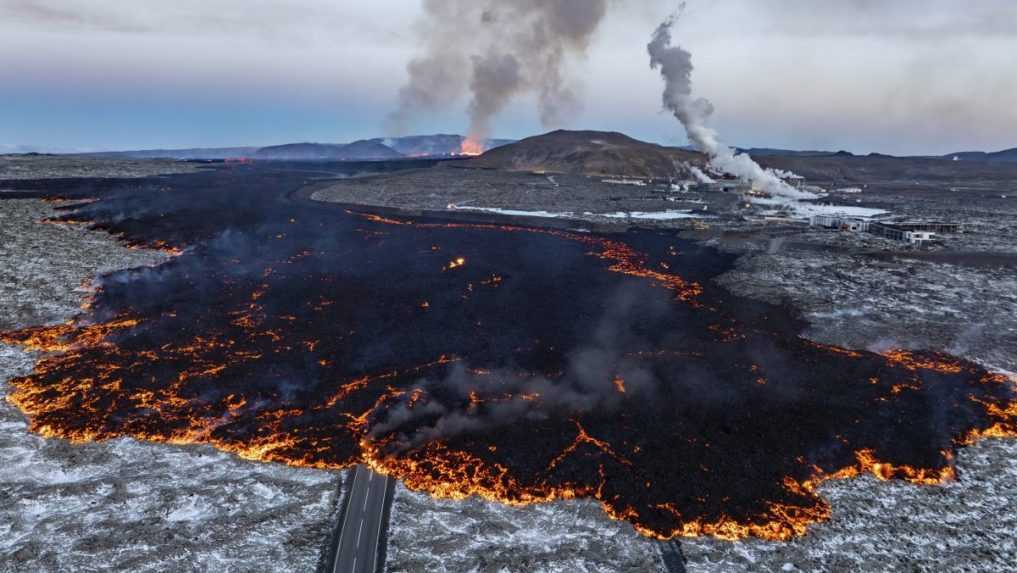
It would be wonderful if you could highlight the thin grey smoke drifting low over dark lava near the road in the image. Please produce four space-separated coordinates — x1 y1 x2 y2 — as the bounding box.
370 288 663 450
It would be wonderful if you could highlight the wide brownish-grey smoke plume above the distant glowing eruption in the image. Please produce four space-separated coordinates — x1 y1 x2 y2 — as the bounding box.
388 0 607 141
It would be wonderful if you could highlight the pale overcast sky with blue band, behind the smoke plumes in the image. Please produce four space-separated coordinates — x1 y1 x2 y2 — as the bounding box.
0 0 1017 154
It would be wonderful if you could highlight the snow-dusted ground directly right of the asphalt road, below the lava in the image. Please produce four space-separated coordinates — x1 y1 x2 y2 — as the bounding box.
387 485 662 573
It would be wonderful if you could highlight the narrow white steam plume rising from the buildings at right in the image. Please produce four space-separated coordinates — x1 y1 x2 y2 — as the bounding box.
647 3 816 199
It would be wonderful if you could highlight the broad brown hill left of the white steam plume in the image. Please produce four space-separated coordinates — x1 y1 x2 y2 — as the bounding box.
465 130 706 178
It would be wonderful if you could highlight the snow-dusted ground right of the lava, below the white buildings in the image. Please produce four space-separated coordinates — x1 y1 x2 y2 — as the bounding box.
720 243 1017 371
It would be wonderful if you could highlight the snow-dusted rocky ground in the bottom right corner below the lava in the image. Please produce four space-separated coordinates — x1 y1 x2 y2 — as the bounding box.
681 440 1017 573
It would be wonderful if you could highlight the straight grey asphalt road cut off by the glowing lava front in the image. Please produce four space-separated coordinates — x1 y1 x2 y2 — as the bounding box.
333 466 390 573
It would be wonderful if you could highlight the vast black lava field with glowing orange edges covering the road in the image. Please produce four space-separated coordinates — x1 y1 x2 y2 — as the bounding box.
0 167 1017 539
